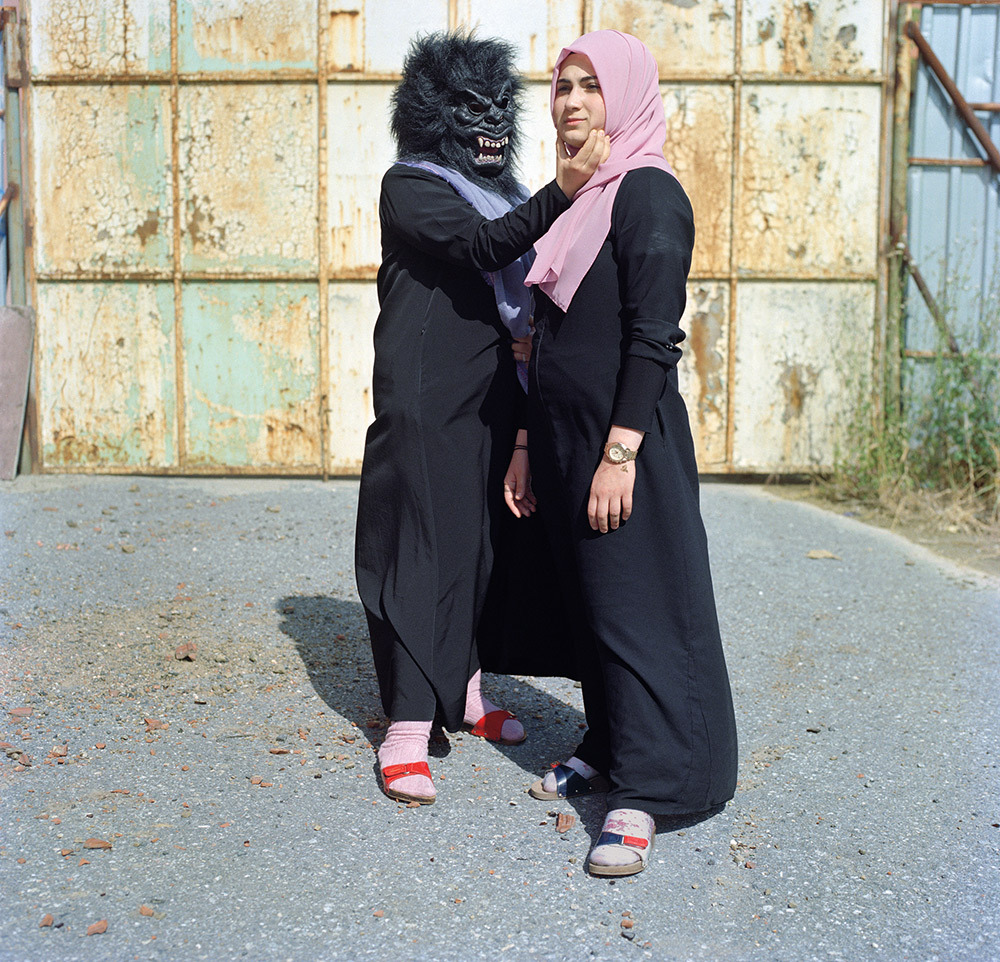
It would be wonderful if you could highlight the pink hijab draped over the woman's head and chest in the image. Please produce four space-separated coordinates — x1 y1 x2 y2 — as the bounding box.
524 30 676 311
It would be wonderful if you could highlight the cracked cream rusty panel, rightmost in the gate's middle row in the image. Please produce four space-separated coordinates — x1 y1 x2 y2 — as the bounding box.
734 84 881 277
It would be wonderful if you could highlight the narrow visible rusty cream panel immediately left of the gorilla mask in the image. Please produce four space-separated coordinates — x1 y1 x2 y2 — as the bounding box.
327 83 396 279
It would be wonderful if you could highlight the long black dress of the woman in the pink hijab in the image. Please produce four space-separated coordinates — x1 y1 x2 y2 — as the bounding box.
528 168 736 815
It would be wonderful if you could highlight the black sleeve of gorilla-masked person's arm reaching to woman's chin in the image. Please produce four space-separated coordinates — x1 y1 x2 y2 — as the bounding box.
379 165 570 271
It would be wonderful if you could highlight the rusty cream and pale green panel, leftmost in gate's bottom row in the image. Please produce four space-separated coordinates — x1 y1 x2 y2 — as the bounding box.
36 283 177 471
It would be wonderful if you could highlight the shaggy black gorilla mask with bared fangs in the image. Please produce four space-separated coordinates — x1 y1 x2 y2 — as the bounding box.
392 32 521 198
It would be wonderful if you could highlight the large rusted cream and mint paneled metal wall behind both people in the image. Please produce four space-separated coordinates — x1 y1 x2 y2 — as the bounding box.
21 0 888 474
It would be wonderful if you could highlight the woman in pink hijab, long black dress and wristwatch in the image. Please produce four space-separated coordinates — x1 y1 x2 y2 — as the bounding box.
508 30 736 875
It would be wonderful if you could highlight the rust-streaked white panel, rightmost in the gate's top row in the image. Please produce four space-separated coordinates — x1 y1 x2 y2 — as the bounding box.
742 0 885 77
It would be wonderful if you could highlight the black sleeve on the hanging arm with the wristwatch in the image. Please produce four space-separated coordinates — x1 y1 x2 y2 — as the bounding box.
611 167 694 431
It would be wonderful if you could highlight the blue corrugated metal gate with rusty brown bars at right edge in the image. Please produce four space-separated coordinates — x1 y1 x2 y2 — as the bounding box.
894 0 1000 396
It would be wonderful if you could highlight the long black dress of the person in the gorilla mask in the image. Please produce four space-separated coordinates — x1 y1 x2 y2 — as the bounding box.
355 165 569 730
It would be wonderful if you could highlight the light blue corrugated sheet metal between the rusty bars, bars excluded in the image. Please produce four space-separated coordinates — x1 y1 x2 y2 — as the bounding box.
904 3 1000 351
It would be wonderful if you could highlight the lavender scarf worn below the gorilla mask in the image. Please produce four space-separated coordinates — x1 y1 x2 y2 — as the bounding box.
397 160 535 391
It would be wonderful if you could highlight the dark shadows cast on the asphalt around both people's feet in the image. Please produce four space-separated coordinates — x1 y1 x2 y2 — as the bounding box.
277 595 724 852
